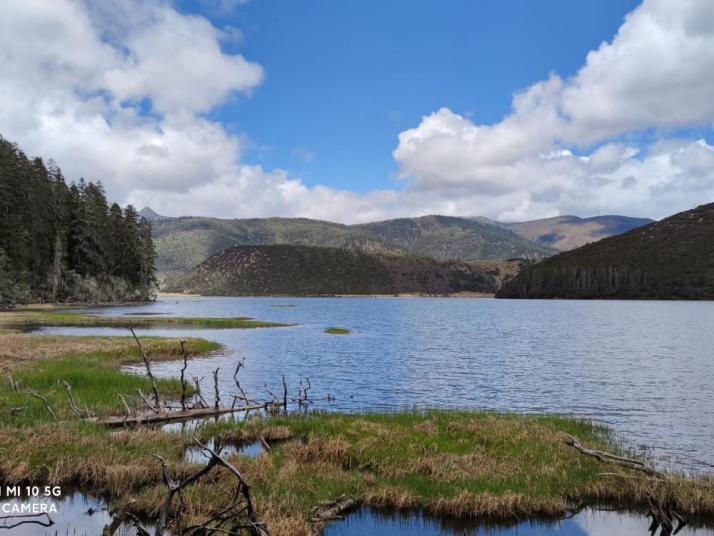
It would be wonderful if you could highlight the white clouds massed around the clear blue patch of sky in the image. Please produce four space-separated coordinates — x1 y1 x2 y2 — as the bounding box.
0 0 714 222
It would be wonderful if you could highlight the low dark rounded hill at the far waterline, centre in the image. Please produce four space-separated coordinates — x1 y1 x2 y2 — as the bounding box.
167 245 508 296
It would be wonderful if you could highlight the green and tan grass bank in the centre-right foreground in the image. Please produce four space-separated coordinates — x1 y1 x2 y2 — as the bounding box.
185 411 714 534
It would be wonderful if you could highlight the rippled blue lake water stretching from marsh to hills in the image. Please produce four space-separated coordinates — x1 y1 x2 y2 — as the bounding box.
43 297 714 472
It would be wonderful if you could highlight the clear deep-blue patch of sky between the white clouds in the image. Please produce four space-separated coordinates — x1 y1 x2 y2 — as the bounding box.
179 0 639 193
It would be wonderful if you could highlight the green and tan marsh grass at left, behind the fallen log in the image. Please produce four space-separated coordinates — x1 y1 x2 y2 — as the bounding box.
0 334 220 426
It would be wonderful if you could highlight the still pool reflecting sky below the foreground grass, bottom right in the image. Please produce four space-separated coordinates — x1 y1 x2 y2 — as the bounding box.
325 509 714 536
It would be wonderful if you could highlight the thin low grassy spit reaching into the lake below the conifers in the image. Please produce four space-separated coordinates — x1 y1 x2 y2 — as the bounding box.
0 309 291 329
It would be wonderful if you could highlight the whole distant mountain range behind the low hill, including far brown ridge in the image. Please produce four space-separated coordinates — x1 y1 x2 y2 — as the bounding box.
140 207 650 282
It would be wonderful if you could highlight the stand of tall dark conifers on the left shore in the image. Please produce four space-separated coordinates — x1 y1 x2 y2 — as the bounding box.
0 137 156 307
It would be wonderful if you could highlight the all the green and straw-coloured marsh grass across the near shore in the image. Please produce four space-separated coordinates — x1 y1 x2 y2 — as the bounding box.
0 313 714 536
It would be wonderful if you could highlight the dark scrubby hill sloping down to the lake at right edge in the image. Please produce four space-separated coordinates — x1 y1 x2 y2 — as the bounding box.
497 203 714 299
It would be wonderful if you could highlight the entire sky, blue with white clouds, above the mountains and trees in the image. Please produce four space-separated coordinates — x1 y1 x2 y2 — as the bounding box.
0 0 714 223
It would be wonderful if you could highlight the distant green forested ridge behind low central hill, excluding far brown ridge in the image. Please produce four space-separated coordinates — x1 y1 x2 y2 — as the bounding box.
149 214 555 280
